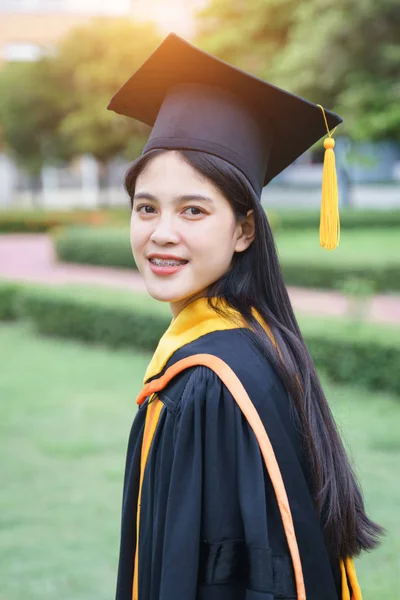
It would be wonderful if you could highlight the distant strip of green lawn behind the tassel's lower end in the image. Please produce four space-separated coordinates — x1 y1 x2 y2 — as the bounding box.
276 228 400 267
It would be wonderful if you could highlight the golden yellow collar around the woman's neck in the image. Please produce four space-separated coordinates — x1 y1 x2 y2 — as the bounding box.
143 297 271 383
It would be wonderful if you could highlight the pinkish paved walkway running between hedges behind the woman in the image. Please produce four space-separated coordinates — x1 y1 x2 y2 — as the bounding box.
0 234 400 325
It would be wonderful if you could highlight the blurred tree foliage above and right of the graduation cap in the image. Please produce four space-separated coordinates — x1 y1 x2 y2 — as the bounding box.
198 0 400 140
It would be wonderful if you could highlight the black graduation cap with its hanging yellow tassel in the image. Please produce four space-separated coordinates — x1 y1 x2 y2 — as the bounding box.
107 33 342 249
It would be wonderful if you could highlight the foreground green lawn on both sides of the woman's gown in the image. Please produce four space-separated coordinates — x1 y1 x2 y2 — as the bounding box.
0 324 400 600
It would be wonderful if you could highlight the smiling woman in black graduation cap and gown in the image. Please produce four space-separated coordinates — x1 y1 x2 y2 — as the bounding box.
110 35 381 600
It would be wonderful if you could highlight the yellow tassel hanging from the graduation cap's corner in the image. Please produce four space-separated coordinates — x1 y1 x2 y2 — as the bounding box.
318 104 340 250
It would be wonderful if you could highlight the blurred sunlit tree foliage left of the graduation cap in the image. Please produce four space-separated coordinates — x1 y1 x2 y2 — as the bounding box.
0 19 160 175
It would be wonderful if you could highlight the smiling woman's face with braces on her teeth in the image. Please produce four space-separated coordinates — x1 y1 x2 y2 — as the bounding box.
131 150 254 316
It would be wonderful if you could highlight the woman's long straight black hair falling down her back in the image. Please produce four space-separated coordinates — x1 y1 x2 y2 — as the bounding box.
125 149 383 558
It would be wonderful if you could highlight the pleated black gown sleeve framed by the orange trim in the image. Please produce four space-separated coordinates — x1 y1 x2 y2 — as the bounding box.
150 366 295 600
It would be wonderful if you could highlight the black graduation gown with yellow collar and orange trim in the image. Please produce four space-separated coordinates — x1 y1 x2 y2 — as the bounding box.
116 298 361 600
